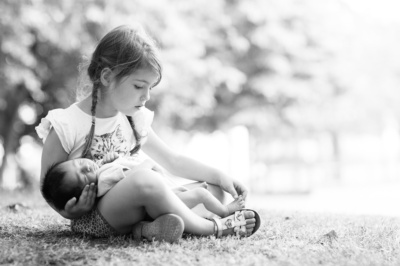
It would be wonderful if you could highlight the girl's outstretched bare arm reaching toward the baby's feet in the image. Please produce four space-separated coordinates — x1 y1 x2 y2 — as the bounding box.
143 128 247 198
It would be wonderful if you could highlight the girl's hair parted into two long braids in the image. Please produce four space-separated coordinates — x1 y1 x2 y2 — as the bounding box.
82 26 162 159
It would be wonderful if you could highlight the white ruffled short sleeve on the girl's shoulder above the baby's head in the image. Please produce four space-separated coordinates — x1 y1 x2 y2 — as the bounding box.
35 109 74 154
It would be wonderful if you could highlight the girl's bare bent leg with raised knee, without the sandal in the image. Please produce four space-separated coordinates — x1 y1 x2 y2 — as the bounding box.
98 170 255 235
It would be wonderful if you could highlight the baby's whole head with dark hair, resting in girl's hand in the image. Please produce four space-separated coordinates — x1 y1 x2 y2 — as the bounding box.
41 158 99 210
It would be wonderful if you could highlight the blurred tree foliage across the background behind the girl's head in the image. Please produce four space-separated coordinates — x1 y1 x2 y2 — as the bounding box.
0 0 400 185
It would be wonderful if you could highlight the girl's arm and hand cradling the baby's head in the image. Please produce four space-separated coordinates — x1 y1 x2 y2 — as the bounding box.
40 129 96 219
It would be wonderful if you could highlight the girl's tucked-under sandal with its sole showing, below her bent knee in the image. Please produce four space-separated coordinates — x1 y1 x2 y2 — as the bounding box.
132 214 185 243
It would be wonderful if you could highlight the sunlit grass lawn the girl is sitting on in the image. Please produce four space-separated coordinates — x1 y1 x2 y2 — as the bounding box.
0 188 400 266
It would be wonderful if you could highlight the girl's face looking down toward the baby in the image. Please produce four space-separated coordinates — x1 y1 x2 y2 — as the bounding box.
104 68 158 115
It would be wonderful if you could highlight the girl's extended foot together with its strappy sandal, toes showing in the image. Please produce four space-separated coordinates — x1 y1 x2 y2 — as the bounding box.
213 209 261 237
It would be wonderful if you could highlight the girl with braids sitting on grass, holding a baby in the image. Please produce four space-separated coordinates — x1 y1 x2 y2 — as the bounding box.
37 23 260 242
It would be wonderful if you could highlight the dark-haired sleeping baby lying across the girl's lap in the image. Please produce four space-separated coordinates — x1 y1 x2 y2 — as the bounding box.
41 153 245 217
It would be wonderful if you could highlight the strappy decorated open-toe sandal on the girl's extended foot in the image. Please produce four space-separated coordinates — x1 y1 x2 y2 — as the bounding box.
212 209 261 238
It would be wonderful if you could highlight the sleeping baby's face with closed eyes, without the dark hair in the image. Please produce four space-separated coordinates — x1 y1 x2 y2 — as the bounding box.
63 158 99 188
